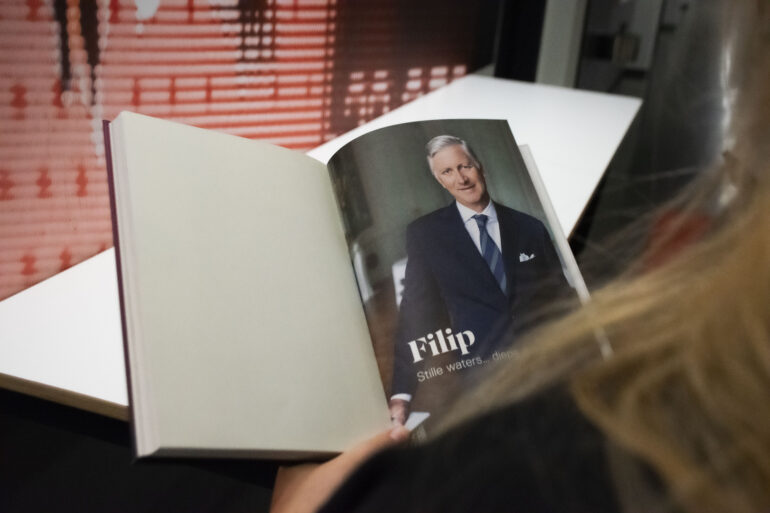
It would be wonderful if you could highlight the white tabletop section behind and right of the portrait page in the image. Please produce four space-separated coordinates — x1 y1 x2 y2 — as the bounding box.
308 75 641 235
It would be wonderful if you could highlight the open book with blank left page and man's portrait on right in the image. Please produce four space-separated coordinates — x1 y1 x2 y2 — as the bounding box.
106 112 584 458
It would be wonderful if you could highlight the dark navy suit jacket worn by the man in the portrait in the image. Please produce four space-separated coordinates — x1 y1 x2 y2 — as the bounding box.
391 202 566 394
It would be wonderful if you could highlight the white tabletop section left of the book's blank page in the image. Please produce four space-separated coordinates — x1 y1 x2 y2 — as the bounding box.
0 248 128 405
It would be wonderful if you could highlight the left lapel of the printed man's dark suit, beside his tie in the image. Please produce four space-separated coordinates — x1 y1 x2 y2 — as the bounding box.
442 203 510 310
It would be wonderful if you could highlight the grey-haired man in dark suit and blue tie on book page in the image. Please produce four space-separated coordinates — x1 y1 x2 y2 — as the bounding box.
390 135 566 423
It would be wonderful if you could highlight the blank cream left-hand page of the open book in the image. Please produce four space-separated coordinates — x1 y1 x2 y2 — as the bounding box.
111 113 388 457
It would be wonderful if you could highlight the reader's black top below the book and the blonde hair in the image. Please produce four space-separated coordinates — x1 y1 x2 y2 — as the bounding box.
321 388 632 513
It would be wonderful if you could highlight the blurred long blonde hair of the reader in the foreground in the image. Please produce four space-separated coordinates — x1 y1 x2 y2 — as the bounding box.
444 0 770 513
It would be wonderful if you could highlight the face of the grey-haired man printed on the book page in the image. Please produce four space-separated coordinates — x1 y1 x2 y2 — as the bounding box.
430 145 489 212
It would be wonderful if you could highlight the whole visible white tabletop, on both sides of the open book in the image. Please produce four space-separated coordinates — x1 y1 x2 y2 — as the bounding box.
0 76 641 405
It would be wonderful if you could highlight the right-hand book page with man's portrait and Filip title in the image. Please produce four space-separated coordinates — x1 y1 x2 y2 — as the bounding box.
328 120 582 431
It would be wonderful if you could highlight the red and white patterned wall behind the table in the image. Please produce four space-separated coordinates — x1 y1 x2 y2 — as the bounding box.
0 0 488 299
